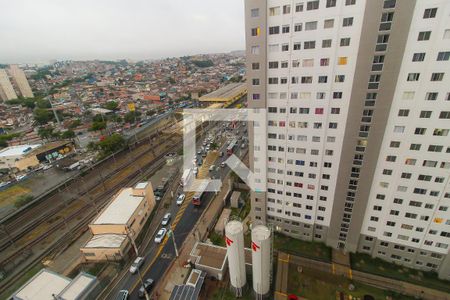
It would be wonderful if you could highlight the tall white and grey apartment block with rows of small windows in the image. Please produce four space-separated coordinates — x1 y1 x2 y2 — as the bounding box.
245 0 450 279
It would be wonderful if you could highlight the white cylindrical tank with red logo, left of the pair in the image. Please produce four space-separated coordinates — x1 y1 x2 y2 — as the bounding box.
225 221 247 290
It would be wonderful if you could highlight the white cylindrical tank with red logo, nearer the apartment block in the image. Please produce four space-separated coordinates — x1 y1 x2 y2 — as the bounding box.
251 225 271 295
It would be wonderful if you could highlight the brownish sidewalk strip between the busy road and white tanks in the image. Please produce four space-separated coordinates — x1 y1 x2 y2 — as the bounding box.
153 176 229 300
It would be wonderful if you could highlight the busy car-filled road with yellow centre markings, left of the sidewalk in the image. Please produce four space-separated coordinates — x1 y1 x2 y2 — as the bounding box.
104 120 248 299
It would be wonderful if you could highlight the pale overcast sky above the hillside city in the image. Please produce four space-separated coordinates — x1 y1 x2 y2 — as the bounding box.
0 0 245 63
